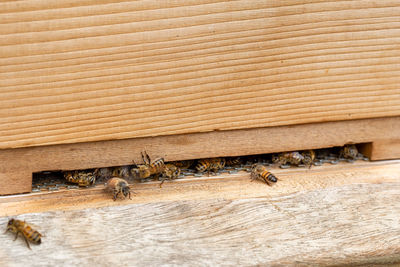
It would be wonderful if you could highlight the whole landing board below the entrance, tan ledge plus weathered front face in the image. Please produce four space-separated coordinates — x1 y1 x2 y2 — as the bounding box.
0 160 400 266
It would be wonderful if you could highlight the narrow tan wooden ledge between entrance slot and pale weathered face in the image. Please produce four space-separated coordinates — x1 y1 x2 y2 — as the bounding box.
0 160 400 216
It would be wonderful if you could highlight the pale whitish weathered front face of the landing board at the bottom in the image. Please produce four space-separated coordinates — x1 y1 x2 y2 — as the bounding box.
0 184 400 266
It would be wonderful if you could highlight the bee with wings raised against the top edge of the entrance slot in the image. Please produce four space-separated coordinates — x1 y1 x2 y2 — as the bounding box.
131 152 165 179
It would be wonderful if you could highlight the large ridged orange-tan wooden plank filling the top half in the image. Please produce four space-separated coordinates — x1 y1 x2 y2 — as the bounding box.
0 0 400 149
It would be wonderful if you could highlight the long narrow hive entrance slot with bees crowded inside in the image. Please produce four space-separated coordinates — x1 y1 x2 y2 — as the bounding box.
32 143 371 193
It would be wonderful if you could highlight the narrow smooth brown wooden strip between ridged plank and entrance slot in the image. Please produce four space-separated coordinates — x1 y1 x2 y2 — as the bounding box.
0 117 400 195
